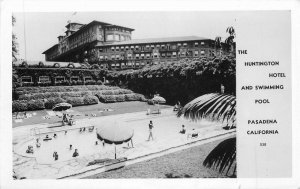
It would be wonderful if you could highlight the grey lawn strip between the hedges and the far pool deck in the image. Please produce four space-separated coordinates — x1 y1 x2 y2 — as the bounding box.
12 101 170 127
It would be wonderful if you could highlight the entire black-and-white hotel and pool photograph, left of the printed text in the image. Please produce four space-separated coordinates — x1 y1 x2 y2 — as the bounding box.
12 11 238 179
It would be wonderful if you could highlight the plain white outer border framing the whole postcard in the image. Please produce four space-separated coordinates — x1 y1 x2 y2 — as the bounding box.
0 0 300 189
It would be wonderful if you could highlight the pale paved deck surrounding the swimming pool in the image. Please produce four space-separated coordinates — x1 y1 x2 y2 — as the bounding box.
13 108 235 179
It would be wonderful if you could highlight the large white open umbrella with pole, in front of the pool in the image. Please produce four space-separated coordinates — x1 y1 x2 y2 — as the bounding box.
95 123 134 159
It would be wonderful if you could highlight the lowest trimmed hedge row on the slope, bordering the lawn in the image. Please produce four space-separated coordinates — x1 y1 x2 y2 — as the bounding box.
12 95 99 112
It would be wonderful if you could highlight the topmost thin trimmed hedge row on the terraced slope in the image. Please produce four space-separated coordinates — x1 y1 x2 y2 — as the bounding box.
16 85 120 95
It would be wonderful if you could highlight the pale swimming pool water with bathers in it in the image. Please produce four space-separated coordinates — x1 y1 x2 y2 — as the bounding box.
18 129 127 164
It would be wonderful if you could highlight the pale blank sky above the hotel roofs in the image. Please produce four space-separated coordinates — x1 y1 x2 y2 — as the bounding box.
13 11 236 61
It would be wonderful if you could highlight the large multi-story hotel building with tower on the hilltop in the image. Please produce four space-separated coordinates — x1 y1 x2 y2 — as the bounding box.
43 21 235 69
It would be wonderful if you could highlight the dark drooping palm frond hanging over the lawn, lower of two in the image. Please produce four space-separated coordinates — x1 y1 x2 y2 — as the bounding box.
203 137 236 175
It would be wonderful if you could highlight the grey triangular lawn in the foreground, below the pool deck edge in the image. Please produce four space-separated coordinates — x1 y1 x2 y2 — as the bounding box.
86 139 234 179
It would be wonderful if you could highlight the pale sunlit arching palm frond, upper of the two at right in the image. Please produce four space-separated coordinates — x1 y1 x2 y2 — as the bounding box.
177 93 236 123
